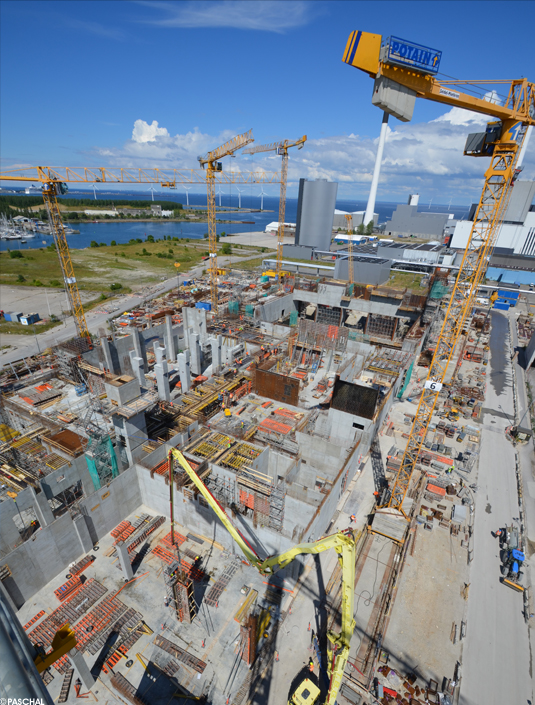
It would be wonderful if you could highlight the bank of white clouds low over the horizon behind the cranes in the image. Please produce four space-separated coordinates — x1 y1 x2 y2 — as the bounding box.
97 108 535 204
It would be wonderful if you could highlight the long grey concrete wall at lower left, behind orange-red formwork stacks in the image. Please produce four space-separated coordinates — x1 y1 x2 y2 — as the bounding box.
0 468 141 608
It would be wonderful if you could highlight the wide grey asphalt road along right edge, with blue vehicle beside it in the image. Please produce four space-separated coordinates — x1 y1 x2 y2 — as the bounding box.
459 312 534 705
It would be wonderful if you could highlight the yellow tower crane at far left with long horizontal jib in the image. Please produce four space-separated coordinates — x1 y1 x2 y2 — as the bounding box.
0 166 280 337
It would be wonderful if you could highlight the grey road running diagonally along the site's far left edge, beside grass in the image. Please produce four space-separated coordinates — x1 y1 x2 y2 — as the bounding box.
0 252 274 367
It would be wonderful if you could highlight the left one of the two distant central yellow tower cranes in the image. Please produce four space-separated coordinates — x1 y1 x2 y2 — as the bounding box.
198 130 254 314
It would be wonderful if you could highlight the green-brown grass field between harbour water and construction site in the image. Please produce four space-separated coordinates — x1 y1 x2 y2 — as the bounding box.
0 240 227 291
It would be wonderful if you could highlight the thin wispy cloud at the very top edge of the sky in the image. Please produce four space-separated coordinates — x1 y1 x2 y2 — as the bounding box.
134 0 318 34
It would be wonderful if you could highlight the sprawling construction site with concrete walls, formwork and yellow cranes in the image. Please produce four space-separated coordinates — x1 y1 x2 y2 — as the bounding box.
0 26 535 705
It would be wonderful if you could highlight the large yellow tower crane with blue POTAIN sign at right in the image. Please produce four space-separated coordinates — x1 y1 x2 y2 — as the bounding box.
342 31 535 512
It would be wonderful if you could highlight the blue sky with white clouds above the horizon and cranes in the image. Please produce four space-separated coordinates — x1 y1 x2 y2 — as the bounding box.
0 0 535 203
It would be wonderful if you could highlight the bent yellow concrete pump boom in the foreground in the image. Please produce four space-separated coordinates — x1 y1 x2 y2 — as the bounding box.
169 448 356 705
